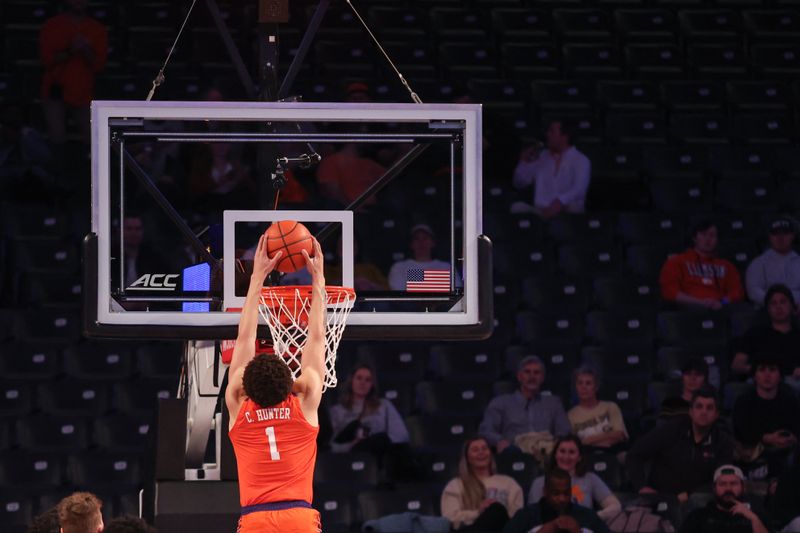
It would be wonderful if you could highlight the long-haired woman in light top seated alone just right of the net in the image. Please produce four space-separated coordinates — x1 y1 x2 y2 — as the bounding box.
329 364 413 478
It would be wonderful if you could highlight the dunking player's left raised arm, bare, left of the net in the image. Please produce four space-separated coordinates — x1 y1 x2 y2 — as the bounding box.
228 235 283 390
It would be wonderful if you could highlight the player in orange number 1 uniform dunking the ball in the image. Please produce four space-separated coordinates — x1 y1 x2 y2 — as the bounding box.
225 235 326 533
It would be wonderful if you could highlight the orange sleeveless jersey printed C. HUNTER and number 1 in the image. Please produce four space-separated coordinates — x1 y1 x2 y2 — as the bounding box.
228 394 319 507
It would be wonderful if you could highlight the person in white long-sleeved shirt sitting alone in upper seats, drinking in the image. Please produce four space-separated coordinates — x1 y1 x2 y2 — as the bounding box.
513 120 592 219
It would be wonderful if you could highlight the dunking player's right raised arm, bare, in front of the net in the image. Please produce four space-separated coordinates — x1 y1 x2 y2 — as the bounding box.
300 239 327 393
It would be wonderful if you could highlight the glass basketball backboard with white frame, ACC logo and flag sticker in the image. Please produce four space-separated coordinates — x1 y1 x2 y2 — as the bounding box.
84 102 493 339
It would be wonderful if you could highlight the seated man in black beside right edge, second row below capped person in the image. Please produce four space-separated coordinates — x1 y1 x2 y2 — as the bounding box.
733 354 800 479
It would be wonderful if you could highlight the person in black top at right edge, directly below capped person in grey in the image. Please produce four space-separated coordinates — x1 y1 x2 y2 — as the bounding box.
731 285 800 381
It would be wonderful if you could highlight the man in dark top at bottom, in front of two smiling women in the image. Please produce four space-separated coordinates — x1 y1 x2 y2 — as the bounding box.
503 468 610 533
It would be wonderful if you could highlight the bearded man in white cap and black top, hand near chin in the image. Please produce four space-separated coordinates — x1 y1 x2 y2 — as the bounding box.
680 465 769 533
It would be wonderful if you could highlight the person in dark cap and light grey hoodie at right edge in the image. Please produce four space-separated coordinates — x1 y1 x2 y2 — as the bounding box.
745 217 800 306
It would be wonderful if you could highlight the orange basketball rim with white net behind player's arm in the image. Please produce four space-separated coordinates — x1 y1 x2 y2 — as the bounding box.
258 285 356 391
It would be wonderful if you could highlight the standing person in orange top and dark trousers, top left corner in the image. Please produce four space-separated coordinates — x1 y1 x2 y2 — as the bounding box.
39 0 108 144
